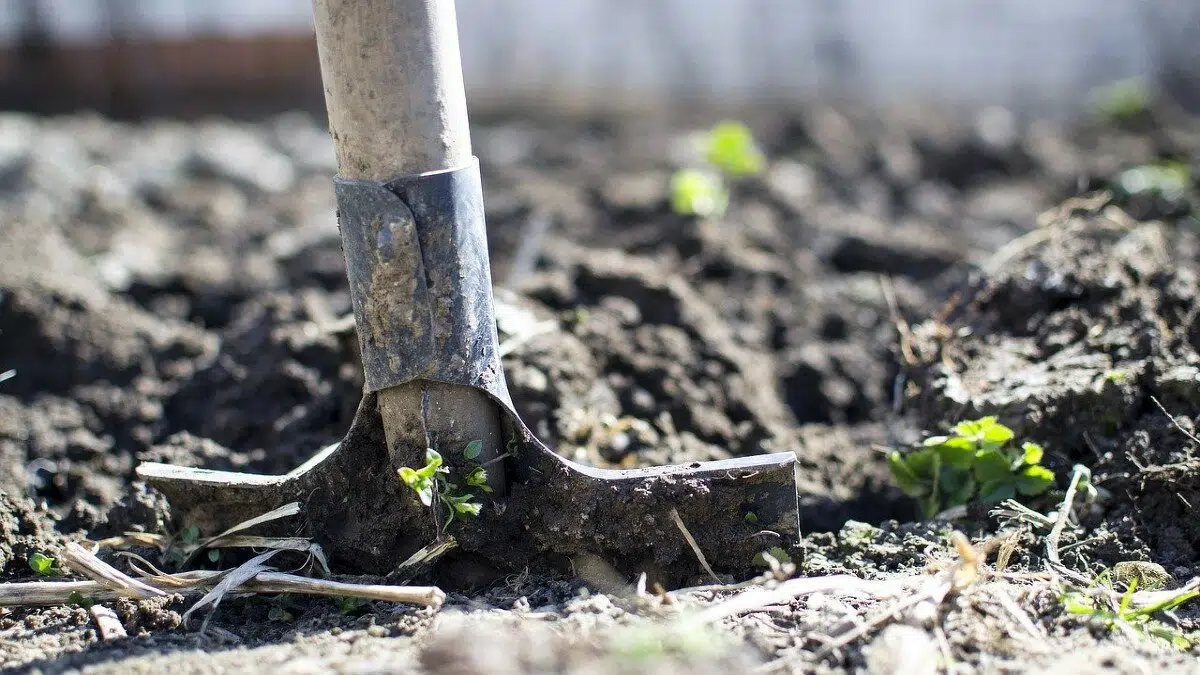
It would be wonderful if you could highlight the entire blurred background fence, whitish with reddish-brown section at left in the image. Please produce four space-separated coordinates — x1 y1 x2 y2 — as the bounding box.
0 0 1200 115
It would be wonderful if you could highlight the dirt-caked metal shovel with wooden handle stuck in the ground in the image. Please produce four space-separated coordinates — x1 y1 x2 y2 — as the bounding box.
137 0 799 585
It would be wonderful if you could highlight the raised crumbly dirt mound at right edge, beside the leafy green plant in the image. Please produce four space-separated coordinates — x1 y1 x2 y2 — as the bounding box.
908 199 1200 578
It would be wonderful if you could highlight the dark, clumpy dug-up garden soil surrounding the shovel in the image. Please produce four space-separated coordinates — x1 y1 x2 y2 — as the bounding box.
0 102 1200 673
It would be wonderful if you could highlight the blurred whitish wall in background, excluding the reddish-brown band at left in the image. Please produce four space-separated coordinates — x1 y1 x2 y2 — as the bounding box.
0 0 1200 113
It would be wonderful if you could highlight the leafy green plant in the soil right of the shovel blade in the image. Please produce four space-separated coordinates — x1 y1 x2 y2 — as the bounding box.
888 417 1055 518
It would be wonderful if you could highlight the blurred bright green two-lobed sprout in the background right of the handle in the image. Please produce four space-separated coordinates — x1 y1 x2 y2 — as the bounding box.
671 121 767 217
